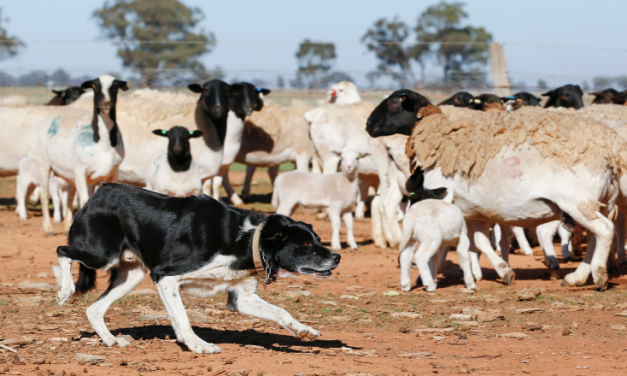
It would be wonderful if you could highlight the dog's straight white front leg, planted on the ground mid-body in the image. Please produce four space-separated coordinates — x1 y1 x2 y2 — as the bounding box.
155 276 220 354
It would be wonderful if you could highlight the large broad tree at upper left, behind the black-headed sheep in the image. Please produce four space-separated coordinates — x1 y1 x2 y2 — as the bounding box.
93 0 216 85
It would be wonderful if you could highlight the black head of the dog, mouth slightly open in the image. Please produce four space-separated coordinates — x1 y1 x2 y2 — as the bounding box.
259 214 341 277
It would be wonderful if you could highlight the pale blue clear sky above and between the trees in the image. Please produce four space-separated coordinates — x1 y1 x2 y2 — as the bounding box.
0 0 627 89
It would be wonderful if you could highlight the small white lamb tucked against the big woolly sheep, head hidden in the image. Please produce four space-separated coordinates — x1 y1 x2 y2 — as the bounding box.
399 199 477 292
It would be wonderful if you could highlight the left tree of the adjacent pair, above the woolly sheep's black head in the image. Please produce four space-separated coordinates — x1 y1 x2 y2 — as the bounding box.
361 18 429 87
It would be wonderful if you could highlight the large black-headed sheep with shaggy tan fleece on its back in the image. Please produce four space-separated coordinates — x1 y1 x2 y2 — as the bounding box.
367 92 627 290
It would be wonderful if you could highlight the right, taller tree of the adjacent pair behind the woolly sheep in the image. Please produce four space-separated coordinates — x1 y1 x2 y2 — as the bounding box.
415 1 492 82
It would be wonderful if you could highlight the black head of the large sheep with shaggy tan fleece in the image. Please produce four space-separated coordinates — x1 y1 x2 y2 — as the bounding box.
366 90 431 137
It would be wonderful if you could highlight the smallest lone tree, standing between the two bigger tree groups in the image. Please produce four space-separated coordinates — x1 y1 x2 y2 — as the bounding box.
292 39 337 89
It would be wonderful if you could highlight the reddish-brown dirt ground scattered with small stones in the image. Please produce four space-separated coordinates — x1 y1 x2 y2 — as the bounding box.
0 173 627 376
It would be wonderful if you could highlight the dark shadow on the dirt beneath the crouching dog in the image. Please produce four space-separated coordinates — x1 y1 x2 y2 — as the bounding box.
81 325 360 353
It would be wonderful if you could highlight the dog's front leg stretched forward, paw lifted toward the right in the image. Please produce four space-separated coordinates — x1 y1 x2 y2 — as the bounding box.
228 278 320 338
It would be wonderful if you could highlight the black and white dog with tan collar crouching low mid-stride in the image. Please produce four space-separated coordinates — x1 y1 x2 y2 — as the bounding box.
54 184 340 353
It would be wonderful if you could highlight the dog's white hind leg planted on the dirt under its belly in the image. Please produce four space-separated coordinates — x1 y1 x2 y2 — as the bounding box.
87 263 146 347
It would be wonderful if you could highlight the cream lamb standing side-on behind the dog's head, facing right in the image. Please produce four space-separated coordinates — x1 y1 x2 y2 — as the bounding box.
272 149 364 250
